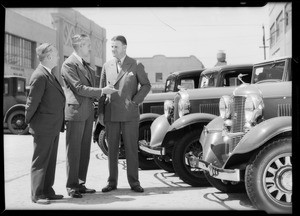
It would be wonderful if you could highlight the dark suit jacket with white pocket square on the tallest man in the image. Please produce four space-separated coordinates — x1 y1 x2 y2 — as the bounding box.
99 56 151 122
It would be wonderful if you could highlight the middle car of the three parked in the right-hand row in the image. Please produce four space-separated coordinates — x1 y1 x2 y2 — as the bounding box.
139 64 253 183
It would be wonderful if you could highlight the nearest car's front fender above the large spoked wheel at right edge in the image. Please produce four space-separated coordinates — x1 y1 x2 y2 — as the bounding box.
232 116 292 155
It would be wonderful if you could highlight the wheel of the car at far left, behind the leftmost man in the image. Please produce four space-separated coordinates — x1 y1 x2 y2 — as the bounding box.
7 110 29 135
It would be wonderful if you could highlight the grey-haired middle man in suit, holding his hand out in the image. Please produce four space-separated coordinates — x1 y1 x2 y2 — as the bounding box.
61 34 114 198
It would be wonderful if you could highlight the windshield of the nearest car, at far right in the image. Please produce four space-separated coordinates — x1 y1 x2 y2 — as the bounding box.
253 61 285 83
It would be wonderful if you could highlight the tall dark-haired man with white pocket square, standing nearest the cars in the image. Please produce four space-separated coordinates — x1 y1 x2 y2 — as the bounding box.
99 35 151 192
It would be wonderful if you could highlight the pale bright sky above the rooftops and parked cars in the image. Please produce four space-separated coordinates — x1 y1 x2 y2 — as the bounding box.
74 6 269 68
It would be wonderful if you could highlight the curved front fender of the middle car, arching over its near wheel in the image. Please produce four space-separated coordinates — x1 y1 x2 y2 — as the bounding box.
168 113 217 132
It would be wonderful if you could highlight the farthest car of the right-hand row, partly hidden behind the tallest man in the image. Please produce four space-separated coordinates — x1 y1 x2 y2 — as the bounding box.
93 69 204 169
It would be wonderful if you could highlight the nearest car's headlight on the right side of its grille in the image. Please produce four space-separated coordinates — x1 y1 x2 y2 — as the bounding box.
245 94 264 124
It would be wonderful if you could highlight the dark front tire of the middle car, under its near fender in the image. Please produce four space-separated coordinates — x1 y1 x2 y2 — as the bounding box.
172 130 210 187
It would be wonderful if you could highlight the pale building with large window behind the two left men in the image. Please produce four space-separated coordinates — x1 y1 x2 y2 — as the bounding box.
4 8 107 85
